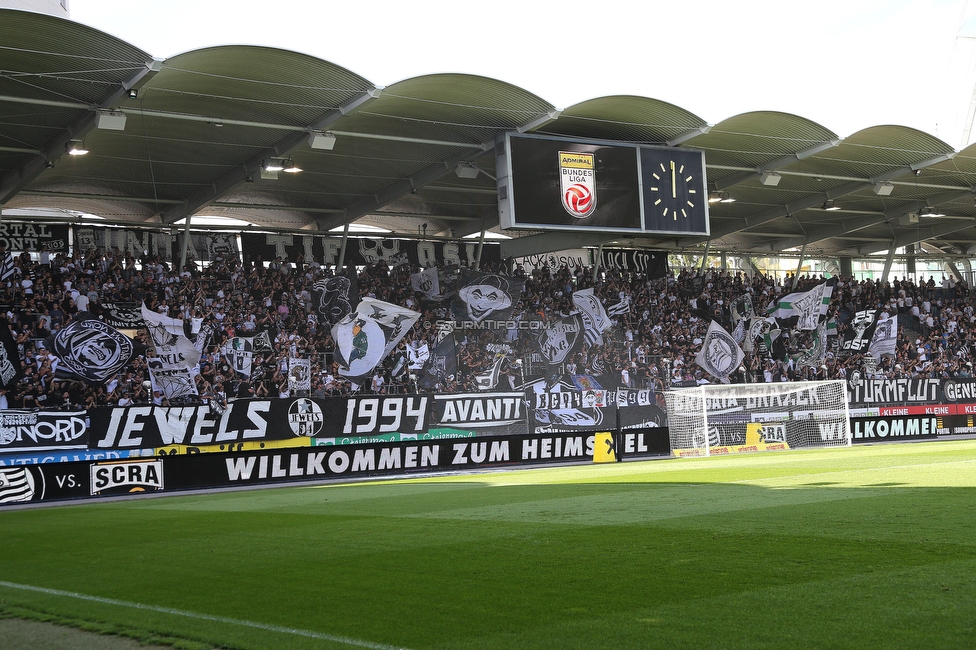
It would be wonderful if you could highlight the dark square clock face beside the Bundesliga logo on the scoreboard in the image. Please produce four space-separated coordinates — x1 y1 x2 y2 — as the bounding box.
641 149 708 232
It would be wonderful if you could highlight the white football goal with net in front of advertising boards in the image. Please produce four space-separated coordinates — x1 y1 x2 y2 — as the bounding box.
665 381 851 456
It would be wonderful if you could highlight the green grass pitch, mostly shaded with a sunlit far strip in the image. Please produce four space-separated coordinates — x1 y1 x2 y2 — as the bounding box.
0 441 976 650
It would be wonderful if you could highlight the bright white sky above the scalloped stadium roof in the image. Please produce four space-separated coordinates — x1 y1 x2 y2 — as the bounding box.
69 0 976 149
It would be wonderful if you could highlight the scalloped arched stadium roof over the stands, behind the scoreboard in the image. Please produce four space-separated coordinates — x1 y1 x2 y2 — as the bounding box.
0 9 976 257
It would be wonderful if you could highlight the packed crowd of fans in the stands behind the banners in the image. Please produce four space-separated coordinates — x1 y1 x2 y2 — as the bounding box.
0 243 976 409
